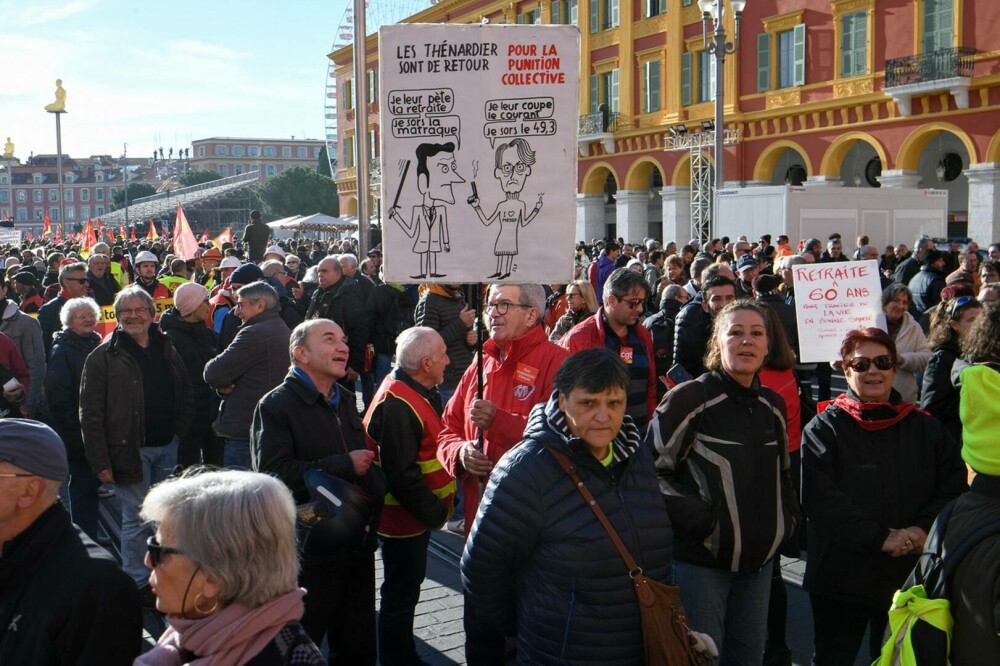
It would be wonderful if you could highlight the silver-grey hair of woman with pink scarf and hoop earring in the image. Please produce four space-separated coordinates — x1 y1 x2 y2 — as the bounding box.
140 470 299 608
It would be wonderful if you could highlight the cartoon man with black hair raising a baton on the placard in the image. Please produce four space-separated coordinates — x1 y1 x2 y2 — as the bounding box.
389 141 465 279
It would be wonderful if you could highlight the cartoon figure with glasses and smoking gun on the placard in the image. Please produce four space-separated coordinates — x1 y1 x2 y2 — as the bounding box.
467 137 544 280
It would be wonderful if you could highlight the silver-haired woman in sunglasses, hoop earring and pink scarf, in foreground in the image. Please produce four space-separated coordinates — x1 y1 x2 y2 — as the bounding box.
135 470 326 666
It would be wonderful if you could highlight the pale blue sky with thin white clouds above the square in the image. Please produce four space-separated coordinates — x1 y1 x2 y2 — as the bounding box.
0 0 371 161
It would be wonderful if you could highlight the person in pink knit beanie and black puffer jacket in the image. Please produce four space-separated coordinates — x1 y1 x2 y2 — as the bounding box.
160 282 223 467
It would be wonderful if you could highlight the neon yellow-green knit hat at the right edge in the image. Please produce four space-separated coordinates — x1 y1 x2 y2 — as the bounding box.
958 365 1000 476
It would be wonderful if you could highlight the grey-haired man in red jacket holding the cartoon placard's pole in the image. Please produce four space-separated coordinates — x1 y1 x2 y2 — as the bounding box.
437 280 568 666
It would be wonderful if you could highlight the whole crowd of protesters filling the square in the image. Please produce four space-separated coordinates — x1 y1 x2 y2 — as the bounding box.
0 213 1000 666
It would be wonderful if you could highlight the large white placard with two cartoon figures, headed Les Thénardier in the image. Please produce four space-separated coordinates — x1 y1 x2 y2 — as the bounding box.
378 24 580 283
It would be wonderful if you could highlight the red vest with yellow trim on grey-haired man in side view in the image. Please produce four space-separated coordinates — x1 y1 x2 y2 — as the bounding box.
364 378 455 538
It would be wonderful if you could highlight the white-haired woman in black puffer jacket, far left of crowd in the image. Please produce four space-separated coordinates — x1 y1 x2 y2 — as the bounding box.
45 298 101 540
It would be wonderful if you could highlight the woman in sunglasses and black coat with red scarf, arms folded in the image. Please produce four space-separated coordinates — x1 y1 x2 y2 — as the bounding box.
802 328 966 666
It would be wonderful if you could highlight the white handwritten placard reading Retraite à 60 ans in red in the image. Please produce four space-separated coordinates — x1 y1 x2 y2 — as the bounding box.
792 259 885 363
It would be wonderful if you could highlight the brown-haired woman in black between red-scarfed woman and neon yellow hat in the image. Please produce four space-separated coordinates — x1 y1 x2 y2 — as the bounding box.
920 285 983 443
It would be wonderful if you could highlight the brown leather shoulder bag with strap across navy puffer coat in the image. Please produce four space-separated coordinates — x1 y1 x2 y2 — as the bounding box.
549 448 708 666
